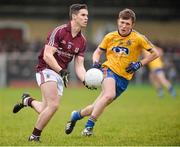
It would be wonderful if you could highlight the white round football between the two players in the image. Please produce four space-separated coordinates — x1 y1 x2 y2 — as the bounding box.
85 68 103 87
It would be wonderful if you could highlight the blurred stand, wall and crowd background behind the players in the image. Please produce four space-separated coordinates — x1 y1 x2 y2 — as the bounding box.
0 0 180 87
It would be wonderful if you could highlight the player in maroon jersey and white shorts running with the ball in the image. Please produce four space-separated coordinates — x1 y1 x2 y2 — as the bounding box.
13 4 92 141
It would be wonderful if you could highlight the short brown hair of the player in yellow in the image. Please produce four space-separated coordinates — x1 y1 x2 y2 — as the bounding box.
119 8 136 23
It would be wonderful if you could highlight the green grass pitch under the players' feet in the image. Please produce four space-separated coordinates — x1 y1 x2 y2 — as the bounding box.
0 85 180 146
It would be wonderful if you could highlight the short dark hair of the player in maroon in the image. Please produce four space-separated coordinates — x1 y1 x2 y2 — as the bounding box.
69 4 88 19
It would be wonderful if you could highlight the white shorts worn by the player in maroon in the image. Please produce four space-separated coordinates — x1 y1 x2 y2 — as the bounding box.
36 69 63 96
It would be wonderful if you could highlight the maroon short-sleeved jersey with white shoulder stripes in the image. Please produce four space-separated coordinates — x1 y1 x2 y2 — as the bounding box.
36 23 86 72
